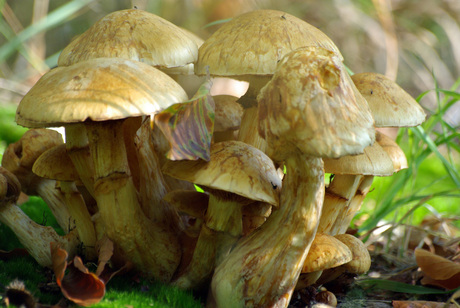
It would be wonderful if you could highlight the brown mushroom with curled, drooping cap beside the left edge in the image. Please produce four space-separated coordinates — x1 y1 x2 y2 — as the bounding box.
2 129 73 233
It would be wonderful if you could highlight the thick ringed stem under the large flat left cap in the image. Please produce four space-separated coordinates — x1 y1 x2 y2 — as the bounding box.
86 121 181 282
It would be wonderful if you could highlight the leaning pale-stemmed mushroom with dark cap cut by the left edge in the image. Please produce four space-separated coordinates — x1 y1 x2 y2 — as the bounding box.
0 167 80 267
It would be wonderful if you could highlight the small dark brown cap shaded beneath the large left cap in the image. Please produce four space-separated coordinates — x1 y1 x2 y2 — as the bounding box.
32 144 80 182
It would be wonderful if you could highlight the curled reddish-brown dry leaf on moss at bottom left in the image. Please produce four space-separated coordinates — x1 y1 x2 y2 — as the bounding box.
51 243 105 306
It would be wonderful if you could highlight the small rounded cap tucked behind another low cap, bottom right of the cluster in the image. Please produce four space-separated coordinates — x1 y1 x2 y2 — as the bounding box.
335 234 371 275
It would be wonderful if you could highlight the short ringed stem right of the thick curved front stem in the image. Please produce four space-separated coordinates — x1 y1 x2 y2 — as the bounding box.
318 175 361 235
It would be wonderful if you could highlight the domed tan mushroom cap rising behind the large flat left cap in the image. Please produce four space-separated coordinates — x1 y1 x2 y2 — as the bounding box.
58 9 198 68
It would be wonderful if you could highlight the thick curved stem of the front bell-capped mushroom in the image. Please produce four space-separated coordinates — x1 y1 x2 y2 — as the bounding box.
211 154 324 307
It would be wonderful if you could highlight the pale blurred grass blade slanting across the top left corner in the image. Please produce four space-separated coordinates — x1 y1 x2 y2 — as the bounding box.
0 0 92 63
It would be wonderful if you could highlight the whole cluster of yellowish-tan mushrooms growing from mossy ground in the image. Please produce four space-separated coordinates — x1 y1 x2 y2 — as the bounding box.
0 9 425 307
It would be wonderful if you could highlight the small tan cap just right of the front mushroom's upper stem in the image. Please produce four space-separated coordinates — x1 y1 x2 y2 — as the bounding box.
323 133 395 176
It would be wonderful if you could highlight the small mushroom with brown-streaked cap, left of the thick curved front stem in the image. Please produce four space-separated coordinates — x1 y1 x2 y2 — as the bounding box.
163 141 281 288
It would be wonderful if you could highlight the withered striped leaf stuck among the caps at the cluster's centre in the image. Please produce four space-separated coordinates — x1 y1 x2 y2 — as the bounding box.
155 79 215 161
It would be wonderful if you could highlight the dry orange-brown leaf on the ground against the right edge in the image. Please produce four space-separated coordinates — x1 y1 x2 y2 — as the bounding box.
415 249 460 290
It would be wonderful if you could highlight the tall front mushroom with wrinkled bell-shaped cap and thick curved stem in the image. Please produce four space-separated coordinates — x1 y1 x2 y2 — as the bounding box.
211 47 375 307
